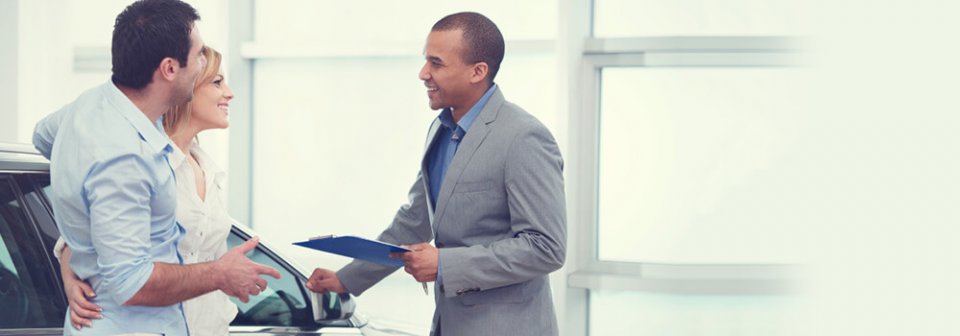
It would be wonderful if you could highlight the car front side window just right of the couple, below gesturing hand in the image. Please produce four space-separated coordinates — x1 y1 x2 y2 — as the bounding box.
227 232 314 326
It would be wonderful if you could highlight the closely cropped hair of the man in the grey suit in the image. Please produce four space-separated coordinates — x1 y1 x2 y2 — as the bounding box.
431 12 504 83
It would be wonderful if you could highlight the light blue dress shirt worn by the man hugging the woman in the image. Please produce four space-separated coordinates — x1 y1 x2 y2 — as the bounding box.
34 82 188 335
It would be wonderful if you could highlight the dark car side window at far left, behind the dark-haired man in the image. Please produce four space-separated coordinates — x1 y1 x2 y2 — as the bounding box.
0 174 66 329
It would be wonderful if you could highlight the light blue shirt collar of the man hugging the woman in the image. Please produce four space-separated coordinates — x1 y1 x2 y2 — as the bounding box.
104 80 173 154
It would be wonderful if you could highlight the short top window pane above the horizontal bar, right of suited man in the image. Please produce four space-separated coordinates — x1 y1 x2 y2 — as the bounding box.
594 0 810 37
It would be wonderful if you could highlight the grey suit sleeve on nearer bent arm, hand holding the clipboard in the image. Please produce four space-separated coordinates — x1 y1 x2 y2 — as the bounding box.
440 126 567 297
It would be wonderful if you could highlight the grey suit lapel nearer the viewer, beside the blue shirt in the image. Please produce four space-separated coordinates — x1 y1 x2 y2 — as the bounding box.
433 88 504 233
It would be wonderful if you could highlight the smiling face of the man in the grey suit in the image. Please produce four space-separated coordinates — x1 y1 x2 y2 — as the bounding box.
420 29 476 112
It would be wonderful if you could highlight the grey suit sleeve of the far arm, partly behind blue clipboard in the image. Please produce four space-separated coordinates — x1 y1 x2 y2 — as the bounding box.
337 173 433 296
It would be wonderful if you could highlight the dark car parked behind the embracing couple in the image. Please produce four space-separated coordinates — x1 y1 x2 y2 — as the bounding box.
0 144 384 335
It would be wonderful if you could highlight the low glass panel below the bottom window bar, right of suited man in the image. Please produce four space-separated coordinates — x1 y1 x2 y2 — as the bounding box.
588 290 800 336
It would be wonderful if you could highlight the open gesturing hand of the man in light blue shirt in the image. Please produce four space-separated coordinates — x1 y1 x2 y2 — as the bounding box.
215 237 280 303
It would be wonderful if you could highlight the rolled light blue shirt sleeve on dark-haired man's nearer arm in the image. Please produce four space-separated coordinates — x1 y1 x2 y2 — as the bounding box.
83 154 155 305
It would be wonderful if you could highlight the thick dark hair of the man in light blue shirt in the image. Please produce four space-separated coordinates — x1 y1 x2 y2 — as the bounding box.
111 0 200 89
